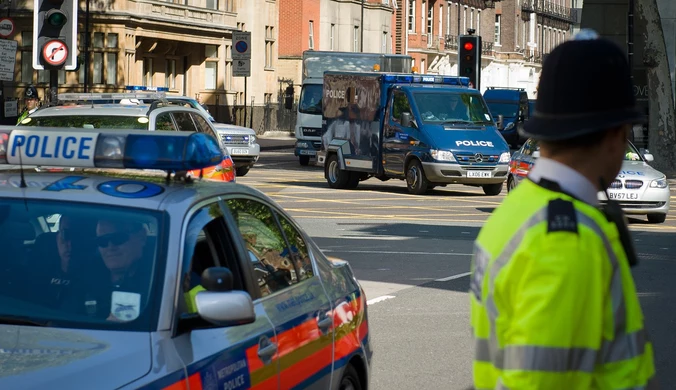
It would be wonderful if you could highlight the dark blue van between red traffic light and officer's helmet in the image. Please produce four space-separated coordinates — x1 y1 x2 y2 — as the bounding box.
484 87 530 148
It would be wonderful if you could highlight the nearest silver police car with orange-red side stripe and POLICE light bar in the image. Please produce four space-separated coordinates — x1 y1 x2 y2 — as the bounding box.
0 127 372 390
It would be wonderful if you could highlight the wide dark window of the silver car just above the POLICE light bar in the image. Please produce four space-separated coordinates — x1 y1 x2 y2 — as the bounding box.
21 115 148 130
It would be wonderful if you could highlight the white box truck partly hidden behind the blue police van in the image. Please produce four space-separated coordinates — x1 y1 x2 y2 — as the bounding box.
286 50 413 165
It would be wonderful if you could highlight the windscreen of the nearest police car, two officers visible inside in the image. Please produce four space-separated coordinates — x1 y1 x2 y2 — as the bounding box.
0 201 163 332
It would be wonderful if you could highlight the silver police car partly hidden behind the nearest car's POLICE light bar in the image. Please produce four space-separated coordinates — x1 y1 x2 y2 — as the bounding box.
15 92 235 182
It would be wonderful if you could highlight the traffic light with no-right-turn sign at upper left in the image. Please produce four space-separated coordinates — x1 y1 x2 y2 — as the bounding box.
33 0 78 70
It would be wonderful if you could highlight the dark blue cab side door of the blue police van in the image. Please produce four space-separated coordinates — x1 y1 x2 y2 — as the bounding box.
383 90 415 175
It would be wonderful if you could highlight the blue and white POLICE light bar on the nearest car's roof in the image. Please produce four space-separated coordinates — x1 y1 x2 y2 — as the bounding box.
0 128 225 171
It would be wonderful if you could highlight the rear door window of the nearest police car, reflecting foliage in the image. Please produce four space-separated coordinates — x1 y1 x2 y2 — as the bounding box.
226 199 307 296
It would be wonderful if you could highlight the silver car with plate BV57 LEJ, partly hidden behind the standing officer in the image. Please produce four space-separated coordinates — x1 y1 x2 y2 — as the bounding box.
507 139 671 223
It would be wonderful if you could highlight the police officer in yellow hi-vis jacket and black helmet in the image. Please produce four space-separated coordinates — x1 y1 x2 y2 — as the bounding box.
470 32 656 390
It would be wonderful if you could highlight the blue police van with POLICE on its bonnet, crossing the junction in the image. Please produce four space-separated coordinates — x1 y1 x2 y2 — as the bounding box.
318 72 510 195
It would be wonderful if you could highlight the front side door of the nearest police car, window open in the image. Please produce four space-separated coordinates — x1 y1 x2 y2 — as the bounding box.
174 201 279 390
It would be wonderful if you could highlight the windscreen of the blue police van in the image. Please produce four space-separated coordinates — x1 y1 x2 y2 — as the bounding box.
413 91 492 124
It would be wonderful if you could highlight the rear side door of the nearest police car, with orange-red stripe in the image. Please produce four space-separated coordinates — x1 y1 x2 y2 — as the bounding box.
226 198 334 390
